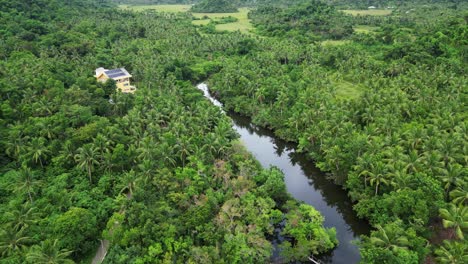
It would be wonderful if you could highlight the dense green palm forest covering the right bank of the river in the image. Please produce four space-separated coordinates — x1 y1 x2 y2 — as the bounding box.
210 1 466 263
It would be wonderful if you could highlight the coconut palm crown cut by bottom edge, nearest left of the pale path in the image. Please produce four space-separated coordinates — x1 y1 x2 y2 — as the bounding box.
26 239 75 264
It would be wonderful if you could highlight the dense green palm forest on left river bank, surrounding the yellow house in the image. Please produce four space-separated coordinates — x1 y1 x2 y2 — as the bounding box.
0 1 338 263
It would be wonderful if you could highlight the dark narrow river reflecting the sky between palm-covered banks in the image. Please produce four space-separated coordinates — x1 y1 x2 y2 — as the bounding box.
197 84 370 264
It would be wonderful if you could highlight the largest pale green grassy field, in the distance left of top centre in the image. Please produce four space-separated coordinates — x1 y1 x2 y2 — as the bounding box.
119 5 253 33
